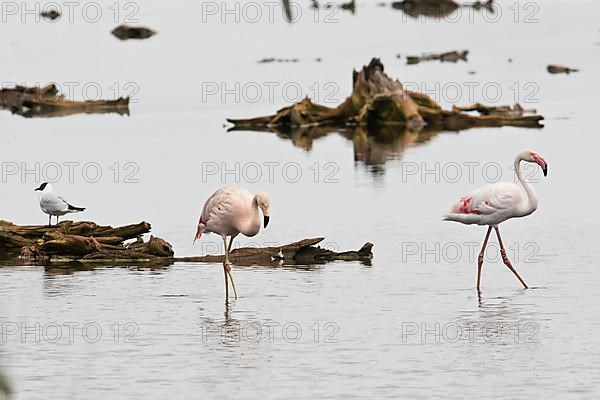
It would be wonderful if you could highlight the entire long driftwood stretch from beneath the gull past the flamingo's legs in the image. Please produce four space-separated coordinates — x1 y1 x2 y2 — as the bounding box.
0 221 373 267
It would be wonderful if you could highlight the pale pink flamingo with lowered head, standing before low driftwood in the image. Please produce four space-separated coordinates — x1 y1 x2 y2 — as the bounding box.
194 186 270 299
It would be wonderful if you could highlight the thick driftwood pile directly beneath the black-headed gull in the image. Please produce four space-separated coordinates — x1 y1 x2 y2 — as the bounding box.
0 221 174 262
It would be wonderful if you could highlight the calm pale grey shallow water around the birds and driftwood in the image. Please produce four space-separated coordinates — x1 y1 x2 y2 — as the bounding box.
0 1 600 399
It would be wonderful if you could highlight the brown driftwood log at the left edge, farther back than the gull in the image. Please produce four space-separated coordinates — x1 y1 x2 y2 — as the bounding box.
0 83 129 117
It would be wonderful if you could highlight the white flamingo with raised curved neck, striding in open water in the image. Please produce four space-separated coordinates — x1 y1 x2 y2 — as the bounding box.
444 150 548 291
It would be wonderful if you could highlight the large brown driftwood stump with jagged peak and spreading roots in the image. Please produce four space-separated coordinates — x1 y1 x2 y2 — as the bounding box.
227 58 543 132
